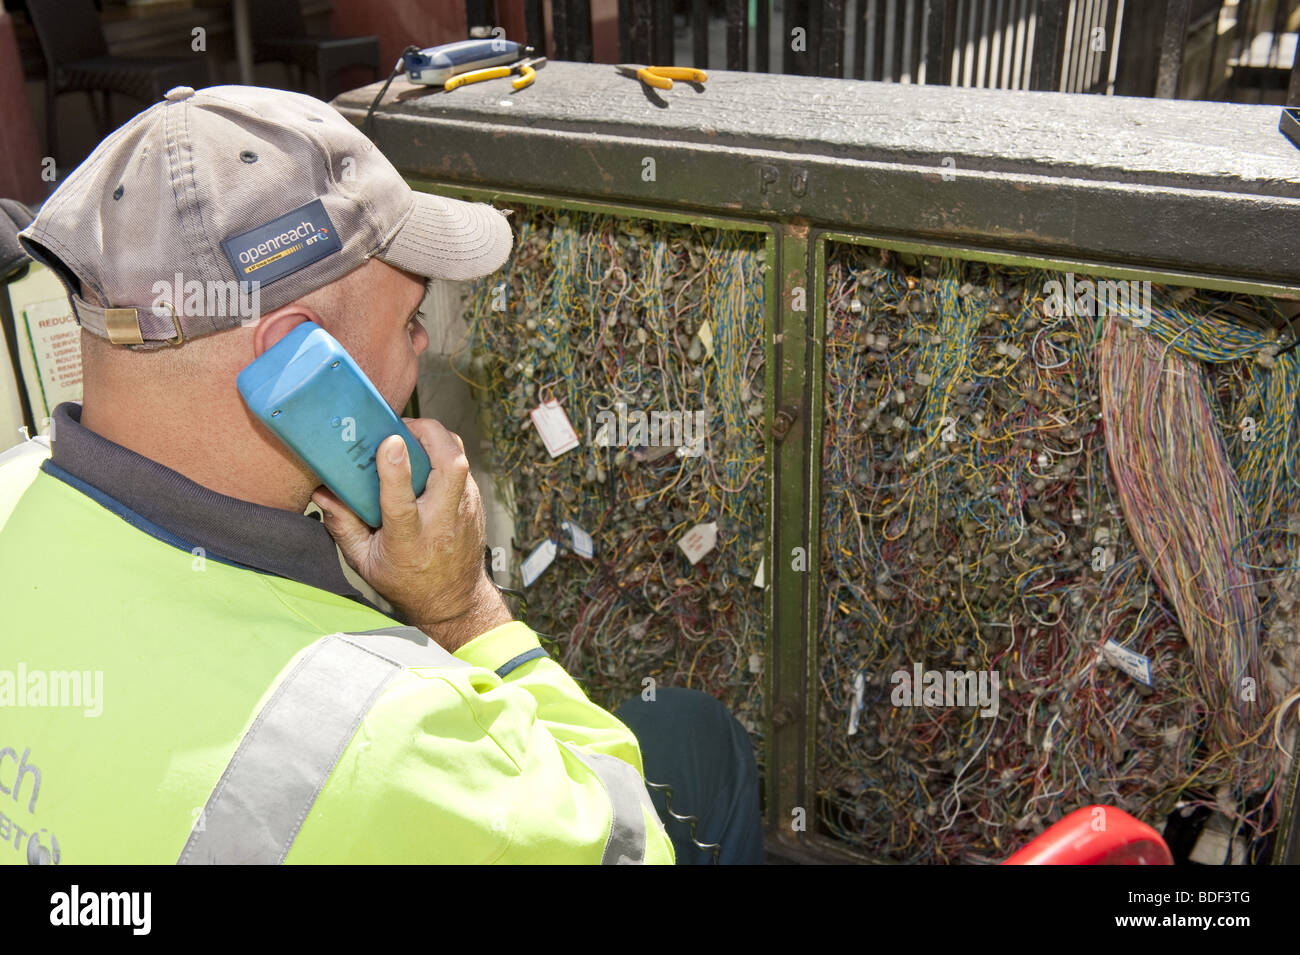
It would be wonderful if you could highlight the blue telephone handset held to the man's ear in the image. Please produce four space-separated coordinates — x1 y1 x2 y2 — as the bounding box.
235 322 430 528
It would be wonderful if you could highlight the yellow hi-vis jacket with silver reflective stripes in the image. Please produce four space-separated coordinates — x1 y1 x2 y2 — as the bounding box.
0 439 673 863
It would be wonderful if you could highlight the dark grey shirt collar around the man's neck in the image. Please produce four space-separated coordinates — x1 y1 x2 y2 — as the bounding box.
42 401 380 609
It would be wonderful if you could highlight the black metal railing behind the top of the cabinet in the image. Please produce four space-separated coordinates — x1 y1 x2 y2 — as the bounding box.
465 0 1300 99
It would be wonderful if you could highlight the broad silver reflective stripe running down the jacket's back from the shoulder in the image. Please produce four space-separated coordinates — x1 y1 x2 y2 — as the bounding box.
177 626 469 865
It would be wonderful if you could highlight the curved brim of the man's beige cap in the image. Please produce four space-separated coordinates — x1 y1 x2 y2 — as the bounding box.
376 192 515 279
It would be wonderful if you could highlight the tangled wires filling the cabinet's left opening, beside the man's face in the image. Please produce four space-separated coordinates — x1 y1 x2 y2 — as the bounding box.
467 205 766 752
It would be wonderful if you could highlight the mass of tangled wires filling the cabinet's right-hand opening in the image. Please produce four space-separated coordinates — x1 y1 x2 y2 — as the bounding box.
818 246 1300 861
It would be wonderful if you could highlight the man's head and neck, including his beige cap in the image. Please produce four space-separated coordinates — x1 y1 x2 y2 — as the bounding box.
20 86 512 508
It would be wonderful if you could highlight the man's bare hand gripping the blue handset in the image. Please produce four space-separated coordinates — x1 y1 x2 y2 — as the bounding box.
312 418 512 652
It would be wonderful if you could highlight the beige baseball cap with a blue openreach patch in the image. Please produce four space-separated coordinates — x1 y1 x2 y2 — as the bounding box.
18 86 514 348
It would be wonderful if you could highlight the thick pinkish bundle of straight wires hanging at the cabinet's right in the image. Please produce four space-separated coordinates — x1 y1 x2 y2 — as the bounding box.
1099 321 1271 793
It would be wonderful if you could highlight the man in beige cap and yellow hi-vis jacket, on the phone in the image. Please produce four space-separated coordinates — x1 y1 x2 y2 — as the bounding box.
0 87 761 863
